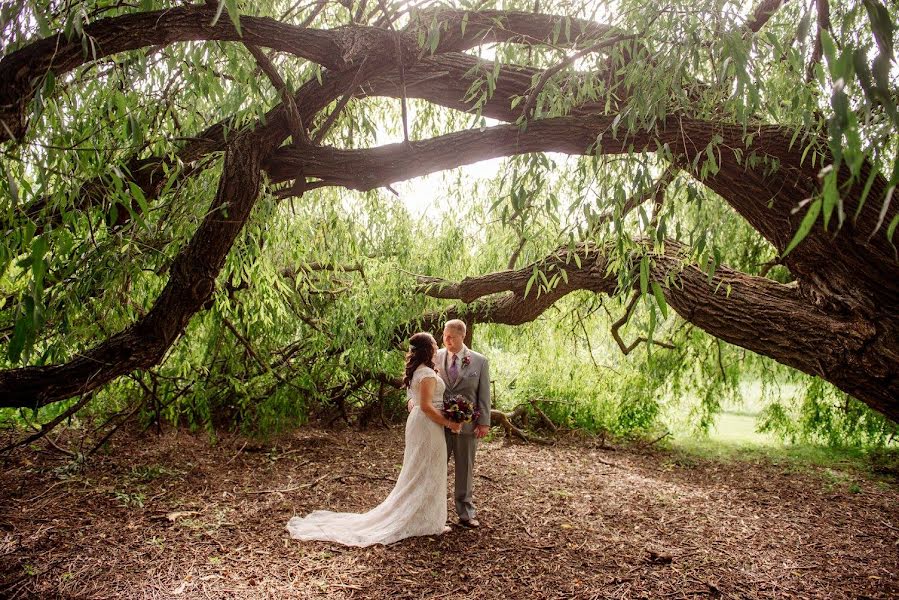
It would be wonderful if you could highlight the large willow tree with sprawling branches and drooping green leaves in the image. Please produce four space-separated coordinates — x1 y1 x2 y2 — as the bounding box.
0 0 899 420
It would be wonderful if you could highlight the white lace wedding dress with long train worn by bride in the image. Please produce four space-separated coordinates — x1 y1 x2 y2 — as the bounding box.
287 365 446 546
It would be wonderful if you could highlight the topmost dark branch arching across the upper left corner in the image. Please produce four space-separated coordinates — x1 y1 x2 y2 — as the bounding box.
0 5 620 142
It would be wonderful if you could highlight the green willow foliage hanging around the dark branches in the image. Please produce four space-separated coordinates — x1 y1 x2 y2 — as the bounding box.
0 0 899 444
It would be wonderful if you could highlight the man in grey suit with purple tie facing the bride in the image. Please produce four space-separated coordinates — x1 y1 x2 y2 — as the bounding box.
434 319 490 527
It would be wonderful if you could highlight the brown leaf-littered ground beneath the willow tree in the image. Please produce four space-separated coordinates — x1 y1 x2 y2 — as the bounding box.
0 427 899 600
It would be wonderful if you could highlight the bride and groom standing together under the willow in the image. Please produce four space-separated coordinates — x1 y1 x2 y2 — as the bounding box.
287 319 490 546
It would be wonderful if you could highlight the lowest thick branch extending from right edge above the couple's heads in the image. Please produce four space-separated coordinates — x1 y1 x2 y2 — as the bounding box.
419 240 899 421
